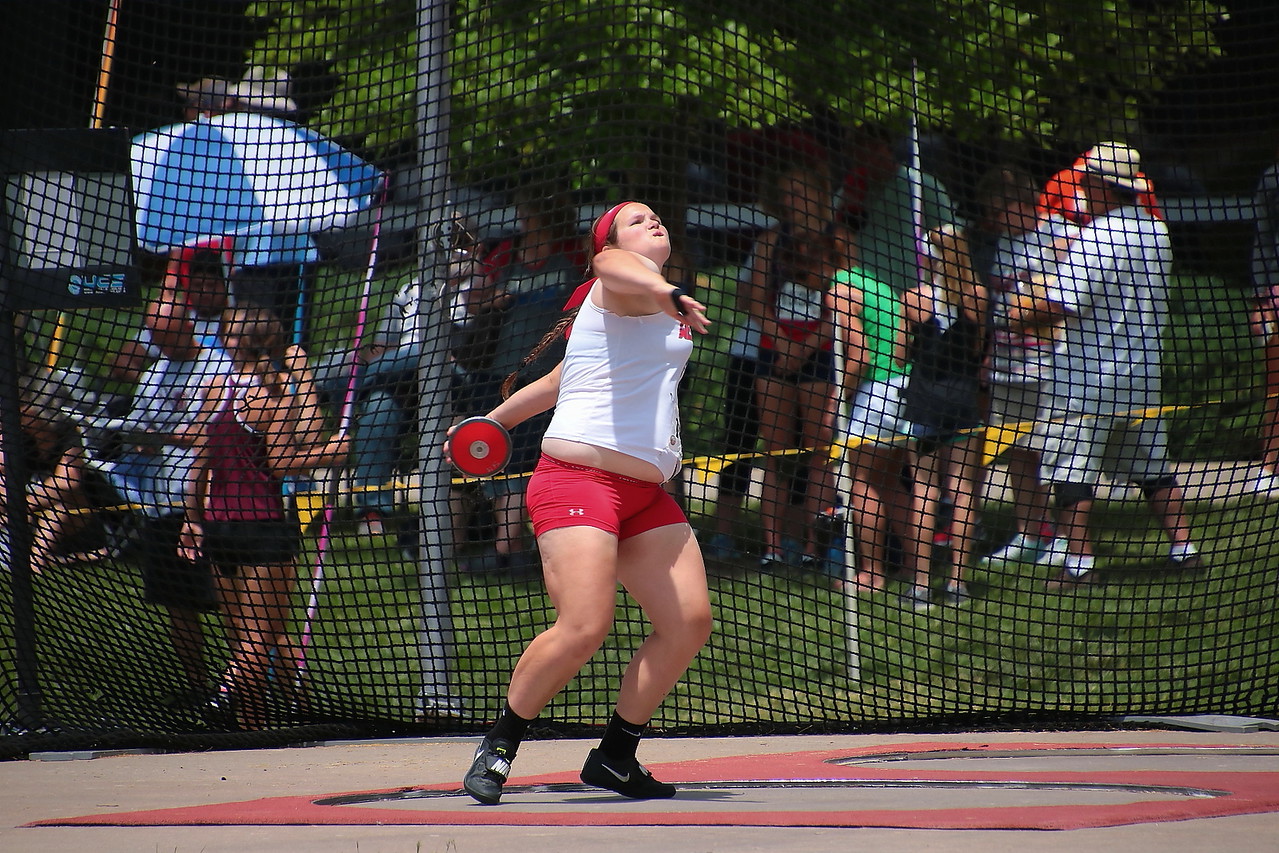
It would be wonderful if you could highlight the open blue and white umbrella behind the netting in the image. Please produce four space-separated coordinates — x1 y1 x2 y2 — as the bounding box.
132 113 381 266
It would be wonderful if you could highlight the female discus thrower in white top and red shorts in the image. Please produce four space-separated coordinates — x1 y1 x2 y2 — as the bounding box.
445 202 711 804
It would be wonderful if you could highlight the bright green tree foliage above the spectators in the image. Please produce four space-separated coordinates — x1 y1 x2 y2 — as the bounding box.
241 0 1224 185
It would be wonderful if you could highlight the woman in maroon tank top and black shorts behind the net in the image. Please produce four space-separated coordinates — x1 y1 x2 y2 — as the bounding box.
179 306 349 729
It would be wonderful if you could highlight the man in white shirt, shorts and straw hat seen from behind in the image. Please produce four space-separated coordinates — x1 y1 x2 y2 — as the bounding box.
1014 142 1202 590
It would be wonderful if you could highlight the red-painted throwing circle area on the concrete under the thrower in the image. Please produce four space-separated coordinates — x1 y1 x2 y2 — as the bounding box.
27 742 1279 829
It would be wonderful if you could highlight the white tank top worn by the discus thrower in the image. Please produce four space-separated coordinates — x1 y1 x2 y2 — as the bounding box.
545 285 693 480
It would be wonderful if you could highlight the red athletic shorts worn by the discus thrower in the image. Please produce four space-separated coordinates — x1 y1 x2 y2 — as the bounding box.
524 454 688 541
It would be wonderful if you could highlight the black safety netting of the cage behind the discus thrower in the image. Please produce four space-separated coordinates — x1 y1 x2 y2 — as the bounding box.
0 0 1279 755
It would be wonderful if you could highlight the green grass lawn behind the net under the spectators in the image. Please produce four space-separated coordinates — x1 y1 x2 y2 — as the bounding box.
3 499 1279 732
